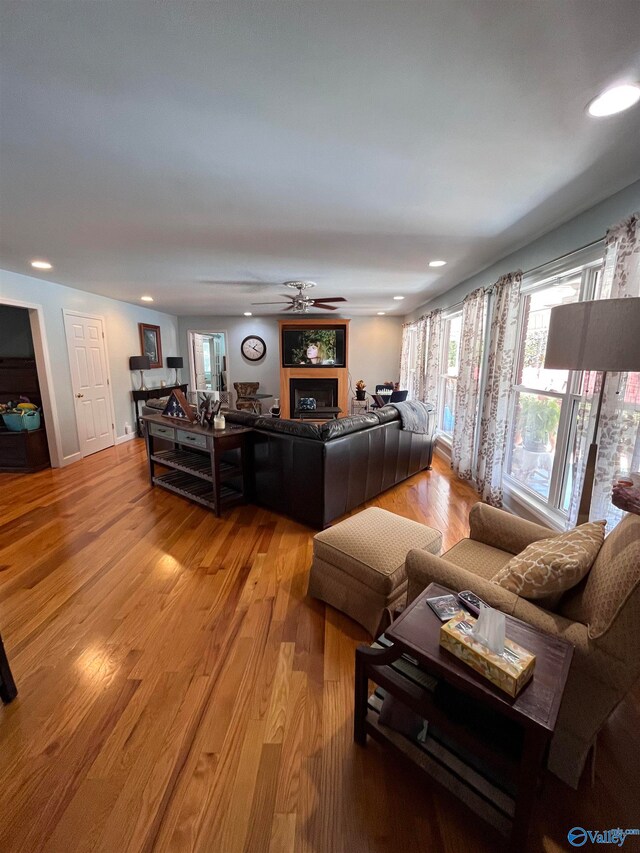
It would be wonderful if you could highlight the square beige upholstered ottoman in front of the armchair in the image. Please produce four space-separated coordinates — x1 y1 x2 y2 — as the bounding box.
309 507 442 637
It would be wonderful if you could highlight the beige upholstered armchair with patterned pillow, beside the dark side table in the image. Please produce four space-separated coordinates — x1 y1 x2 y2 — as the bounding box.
406 503 640 788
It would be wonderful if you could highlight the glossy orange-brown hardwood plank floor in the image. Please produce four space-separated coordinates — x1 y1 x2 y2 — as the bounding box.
0 441 640 853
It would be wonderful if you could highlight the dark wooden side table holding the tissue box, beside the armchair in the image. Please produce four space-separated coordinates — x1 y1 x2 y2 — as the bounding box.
354 584 573 853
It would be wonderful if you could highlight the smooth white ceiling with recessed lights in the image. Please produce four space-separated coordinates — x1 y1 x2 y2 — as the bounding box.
0 0 640 315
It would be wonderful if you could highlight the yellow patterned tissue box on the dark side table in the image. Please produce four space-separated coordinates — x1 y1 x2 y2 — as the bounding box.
440 616 536 697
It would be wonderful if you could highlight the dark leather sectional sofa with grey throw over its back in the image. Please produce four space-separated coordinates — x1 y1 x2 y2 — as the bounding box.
227 406 435 528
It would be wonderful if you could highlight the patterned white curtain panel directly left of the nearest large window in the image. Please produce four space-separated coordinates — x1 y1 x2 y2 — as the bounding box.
477 272 522 507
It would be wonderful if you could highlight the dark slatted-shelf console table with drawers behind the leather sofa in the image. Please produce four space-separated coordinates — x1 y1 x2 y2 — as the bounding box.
142 415 251 516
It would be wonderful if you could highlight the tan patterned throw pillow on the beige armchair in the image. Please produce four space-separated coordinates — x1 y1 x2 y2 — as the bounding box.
491 521 607 607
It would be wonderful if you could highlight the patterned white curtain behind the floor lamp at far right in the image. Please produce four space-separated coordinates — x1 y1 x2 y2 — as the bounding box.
567 214 640 530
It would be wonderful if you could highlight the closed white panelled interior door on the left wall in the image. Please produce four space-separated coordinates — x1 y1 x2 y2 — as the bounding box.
64 313 114 456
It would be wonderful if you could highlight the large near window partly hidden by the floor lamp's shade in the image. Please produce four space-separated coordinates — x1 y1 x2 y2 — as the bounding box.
506 261 601 515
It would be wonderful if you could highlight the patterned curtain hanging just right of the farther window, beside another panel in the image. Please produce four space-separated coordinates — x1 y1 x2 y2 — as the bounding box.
451 288 487 480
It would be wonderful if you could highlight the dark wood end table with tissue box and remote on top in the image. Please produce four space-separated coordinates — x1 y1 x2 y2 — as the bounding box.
354 584 573 853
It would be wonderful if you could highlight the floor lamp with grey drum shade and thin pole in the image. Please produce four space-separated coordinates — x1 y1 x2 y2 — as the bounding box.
544 297 640 524
